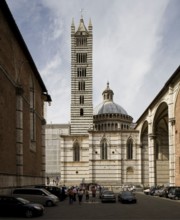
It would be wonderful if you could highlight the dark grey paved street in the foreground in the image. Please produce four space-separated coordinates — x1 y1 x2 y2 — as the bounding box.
3 193 180 220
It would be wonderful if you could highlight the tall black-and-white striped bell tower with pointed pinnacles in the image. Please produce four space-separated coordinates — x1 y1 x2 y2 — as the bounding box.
71 16 93 135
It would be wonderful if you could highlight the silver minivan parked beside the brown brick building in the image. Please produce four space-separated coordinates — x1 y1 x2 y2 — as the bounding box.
12 188 59 206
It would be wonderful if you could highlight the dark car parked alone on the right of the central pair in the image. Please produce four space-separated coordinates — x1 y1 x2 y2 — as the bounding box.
118 191 137 203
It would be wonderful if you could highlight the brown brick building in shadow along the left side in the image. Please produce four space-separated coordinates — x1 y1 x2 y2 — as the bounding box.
0 0 51 193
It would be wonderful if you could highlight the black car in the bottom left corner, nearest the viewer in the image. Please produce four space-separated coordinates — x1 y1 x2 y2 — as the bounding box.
0 195 44 218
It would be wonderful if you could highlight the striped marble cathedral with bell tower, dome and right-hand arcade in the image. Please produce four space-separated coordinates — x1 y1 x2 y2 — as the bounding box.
45 17 180 186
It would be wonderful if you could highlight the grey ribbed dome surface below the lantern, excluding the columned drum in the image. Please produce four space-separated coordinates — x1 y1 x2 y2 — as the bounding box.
94 101 127 115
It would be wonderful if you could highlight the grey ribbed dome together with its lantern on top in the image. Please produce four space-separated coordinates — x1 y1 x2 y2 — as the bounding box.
94 83 127 115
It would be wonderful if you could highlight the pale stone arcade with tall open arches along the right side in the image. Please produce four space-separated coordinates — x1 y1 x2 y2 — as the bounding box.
135 66 180 185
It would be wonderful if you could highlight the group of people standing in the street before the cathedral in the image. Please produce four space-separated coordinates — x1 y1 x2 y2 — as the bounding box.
68 186 96 205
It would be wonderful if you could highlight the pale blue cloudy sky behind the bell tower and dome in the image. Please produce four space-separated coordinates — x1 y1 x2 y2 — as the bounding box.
6 0 180 124
